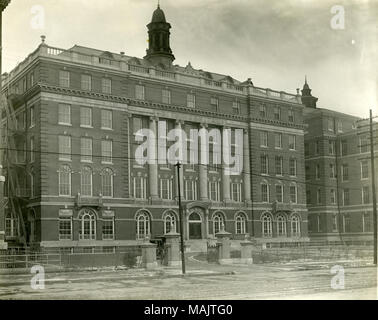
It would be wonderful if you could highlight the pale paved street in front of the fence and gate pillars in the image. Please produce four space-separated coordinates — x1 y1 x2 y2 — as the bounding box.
0 259 377 300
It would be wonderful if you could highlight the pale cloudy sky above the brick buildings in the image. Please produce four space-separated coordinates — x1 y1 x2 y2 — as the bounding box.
3 0 378 117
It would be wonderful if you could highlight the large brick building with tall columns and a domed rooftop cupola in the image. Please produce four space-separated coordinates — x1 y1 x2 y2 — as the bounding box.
2 3 308 251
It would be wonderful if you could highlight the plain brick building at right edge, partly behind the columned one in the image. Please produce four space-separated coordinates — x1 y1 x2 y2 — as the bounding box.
302 81 377 243
